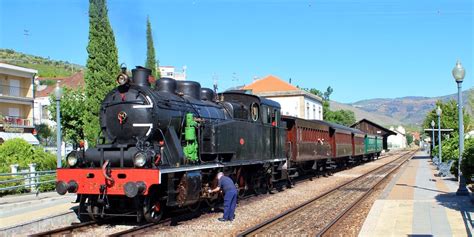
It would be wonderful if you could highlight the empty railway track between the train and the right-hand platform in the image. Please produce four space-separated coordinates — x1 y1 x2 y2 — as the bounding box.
239 151 416 236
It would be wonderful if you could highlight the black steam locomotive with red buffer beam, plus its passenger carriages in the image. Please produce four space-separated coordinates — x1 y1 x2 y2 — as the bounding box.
56 67 382 222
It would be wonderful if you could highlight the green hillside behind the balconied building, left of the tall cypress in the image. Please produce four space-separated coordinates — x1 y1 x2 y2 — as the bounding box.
0 49 84 78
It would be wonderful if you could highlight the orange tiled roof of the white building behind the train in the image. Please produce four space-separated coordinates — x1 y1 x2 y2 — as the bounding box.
242 75 298 94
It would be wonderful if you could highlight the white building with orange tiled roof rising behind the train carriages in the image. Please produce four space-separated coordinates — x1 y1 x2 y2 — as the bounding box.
242 75 323 120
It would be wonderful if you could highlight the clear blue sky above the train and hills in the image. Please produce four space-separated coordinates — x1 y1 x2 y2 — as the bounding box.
0 0 474 103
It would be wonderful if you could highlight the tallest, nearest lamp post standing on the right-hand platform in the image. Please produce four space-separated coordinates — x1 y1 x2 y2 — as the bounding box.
452 60 469 196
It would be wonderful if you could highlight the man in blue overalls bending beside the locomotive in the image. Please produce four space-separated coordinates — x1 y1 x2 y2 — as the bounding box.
209 172 237 221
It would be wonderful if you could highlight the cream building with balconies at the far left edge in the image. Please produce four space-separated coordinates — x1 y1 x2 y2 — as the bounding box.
0 63 39 145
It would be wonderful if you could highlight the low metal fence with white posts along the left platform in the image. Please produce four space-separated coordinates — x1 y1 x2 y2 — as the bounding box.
0 164 56 192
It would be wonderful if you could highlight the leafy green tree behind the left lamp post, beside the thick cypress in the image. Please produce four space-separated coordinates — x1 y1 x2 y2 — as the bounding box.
49 87 88 145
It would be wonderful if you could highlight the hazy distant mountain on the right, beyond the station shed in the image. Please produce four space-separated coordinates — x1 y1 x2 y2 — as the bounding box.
344 88 474 126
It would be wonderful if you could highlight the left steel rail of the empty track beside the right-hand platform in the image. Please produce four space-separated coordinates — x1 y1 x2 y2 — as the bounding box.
238 151 414 236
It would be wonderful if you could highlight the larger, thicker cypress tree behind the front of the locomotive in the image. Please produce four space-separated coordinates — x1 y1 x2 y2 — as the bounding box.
83 0 120 145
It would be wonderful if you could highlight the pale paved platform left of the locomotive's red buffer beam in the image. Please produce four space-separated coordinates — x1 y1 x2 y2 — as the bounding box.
0 192 78 231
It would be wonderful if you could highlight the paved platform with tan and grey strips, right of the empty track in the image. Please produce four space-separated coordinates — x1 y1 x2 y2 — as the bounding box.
359 152 474 237
